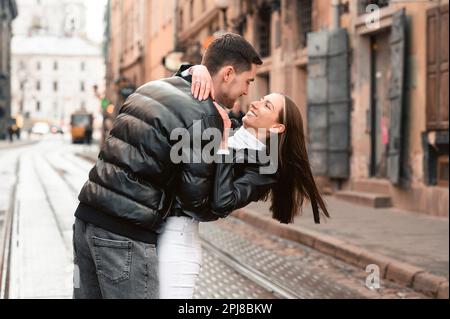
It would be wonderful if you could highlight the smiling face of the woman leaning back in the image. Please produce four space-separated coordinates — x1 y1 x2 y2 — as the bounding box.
243 93 285 133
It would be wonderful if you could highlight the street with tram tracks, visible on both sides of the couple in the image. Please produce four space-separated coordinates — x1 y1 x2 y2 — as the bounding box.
0 136 426 299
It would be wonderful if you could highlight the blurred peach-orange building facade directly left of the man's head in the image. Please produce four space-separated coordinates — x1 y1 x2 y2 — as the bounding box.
105 0 176 111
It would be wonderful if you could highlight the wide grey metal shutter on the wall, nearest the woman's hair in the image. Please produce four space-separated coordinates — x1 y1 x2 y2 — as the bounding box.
308 29 350 178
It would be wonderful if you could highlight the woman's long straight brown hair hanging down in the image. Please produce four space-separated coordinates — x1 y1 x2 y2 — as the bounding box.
270 96 330 224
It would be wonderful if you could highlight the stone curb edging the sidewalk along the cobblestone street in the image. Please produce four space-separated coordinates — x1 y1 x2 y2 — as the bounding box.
233 209 449 299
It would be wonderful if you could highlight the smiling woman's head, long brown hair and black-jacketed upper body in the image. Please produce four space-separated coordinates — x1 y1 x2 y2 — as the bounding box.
213 93 329 224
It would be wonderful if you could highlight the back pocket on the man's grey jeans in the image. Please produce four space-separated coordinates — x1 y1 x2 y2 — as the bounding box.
92 236 133 283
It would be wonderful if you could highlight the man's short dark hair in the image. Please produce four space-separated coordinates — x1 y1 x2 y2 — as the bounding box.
202 33 263 75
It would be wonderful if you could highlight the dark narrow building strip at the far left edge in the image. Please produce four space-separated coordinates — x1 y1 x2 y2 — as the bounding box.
0 0 18 140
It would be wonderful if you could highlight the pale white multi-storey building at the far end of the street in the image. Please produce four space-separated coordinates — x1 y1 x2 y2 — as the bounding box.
12 0 105 130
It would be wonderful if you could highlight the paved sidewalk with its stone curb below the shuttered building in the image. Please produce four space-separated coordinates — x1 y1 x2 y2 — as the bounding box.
235 200 449 298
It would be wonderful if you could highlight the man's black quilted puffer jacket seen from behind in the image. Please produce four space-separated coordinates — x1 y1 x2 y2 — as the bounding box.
75 70 227 243
